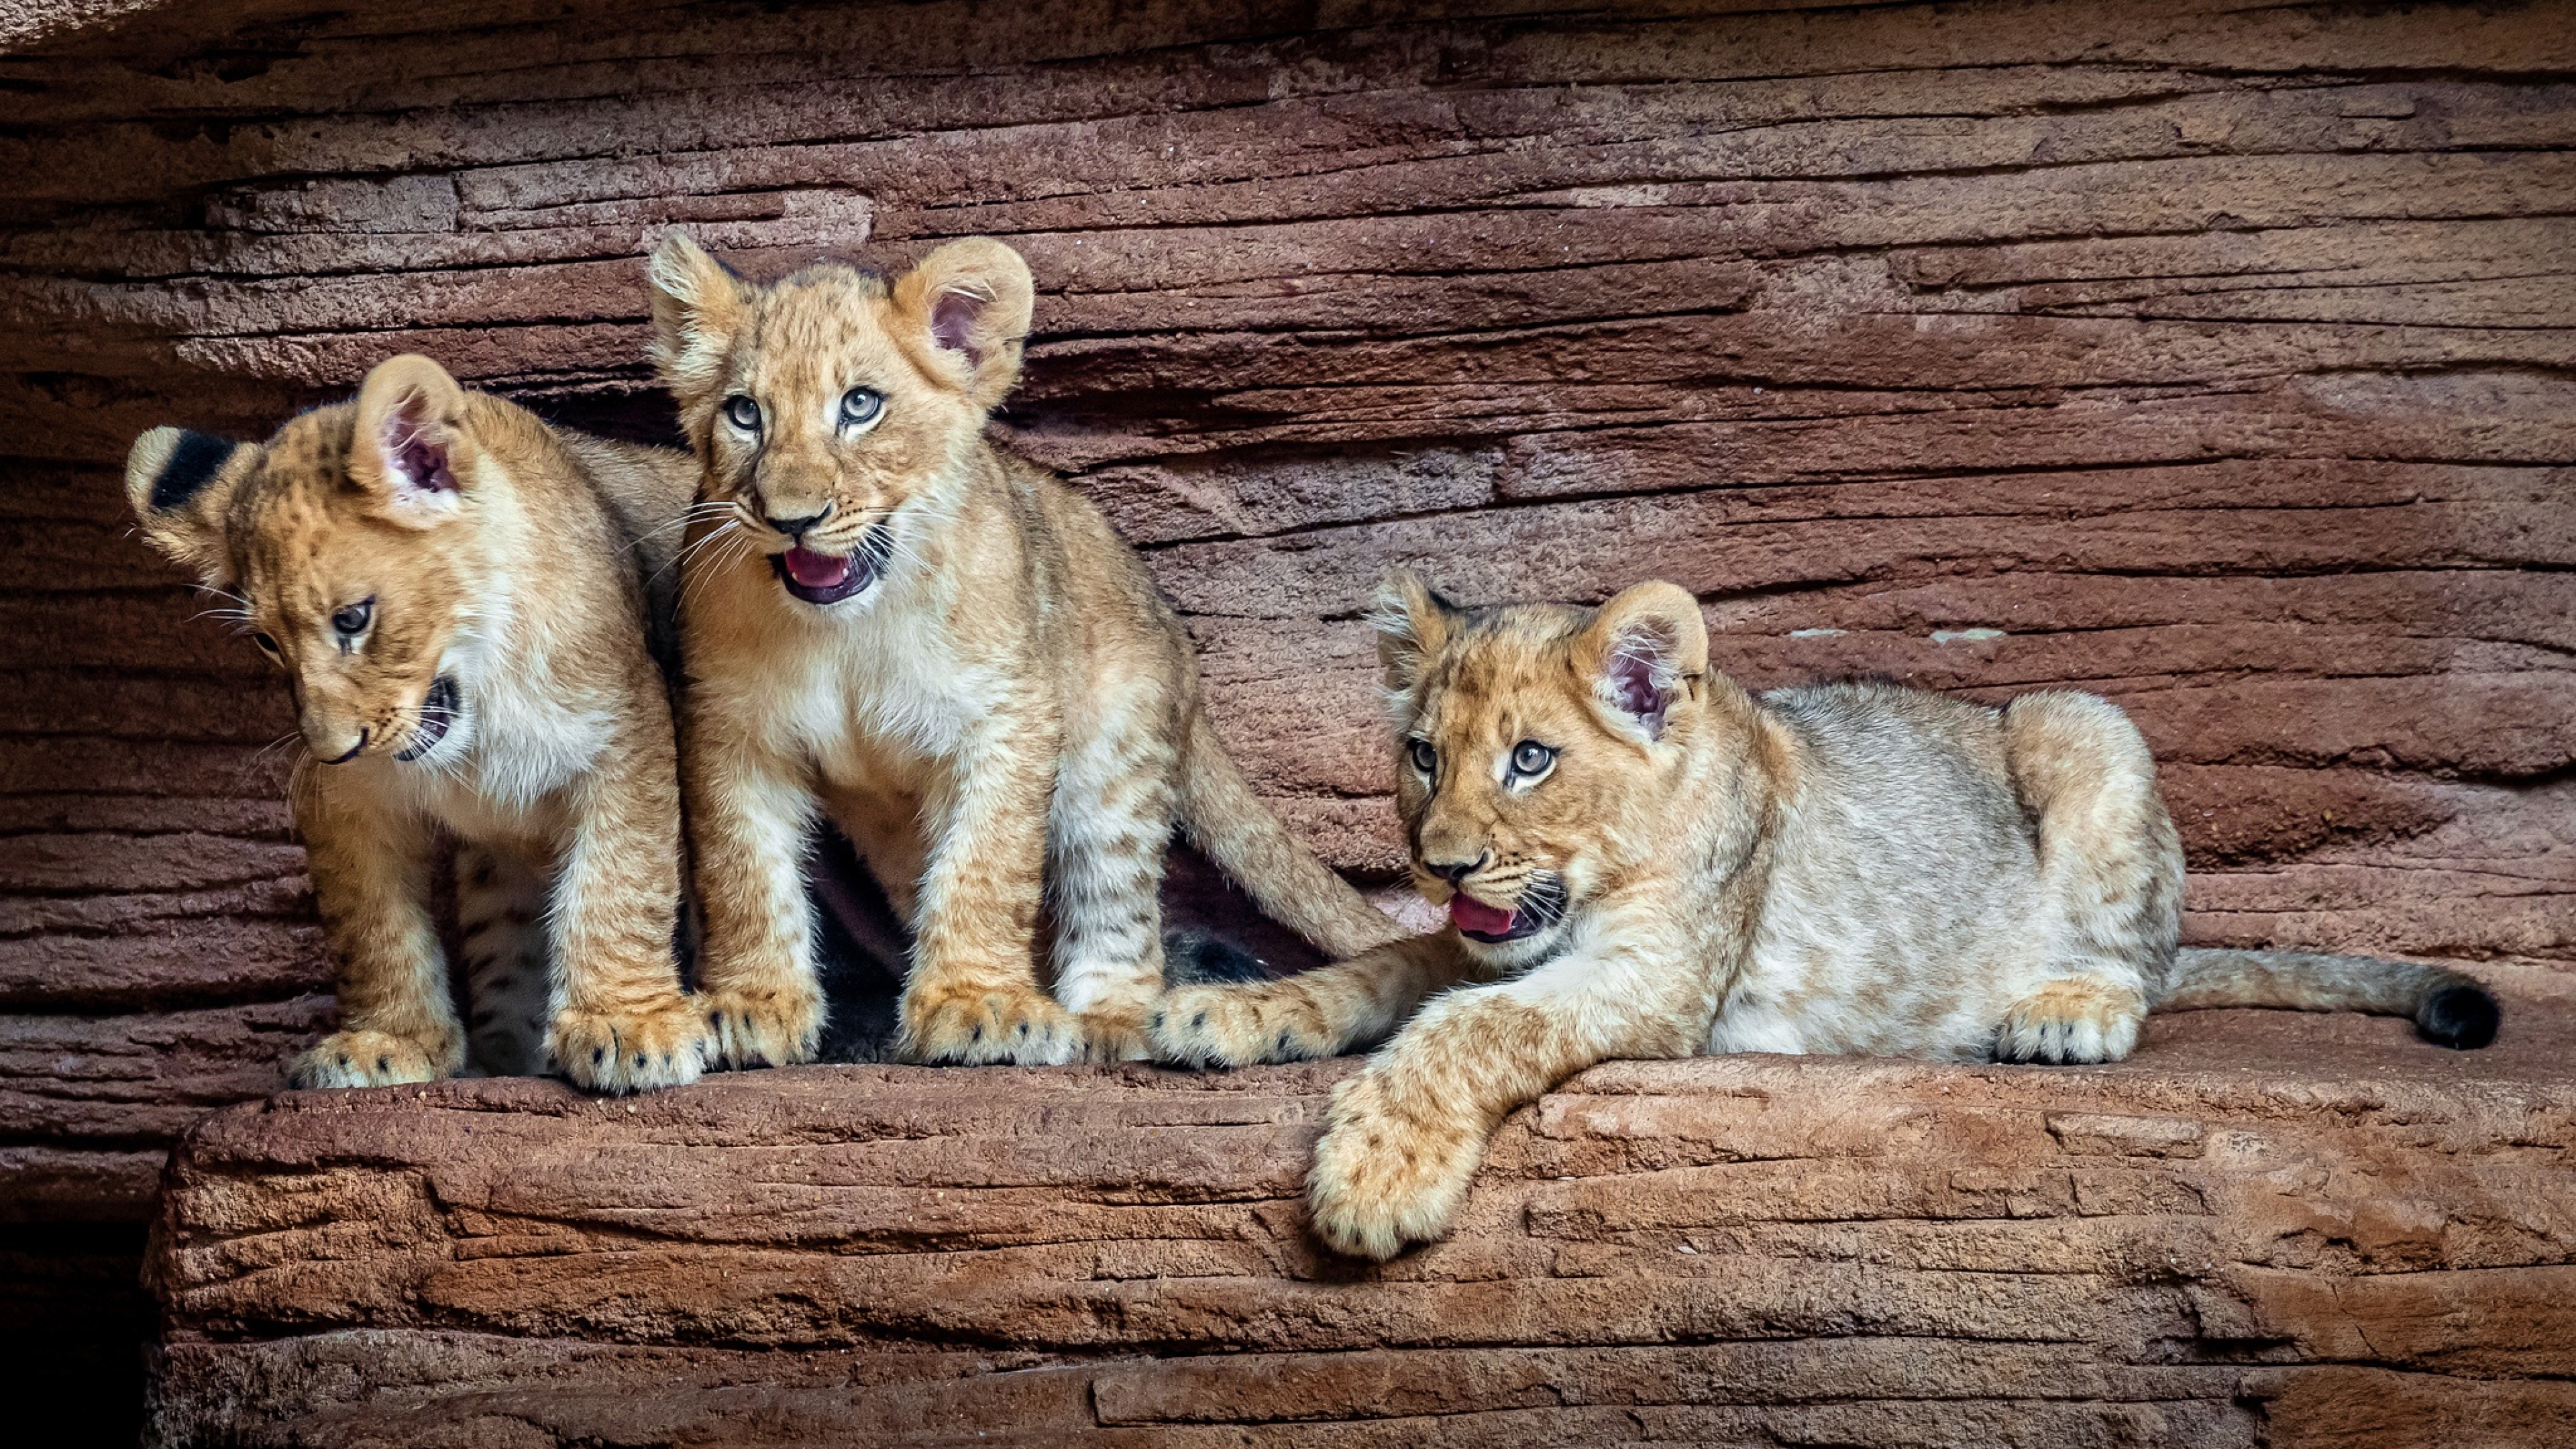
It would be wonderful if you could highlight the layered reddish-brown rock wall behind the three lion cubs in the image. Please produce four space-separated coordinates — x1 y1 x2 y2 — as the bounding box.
0 0 2576 1433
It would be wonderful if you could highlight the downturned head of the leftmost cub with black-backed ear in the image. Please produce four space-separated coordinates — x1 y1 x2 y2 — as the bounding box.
126 356 499 763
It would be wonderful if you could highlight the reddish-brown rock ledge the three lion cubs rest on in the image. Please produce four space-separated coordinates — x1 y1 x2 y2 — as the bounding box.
150 972 2576 1449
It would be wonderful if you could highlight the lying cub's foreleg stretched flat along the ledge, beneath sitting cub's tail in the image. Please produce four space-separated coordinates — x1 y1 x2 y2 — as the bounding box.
1151 930 1473 1067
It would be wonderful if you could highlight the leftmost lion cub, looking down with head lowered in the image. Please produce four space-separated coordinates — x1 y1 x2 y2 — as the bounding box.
126 356 706 1091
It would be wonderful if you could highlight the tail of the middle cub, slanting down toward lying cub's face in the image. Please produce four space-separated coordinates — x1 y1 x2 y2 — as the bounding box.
1180 714 1404 962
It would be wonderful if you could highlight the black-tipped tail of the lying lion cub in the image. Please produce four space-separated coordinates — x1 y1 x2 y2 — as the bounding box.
2156 947 2504 1052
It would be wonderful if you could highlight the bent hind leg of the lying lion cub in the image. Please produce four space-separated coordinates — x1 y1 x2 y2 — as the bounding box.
1994 694 2182 1062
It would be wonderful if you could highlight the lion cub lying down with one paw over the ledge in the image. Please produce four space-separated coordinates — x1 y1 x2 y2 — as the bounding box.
1154 575 2496 1258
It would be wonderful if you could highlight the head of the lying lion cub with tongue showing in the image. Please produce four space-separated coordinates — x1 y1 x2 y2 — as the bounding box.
1371 572 1711 967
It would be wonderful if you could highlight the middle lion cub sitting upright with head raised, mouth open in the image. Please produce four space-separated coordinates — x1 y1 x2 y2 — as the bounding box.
652 235 1399 1065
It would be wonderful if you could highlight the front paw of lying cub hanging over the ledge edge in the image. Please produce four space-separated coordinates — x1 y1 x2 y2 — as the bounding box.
1306 1067 1484 1260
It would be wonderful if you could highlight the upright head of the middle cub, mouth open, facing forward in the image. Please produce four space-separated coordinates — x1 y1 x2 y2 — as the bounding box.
652 232 1033 603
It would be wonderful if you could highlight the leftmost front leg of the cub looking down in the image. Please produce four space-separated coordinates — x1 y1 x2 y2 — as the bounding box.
286 771 466 1088
